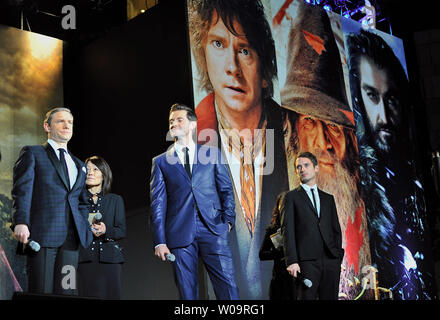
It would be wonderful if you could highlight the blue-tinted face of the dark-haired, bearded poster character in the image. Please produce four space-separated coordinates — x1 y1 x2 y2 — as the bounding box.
359 57 400 153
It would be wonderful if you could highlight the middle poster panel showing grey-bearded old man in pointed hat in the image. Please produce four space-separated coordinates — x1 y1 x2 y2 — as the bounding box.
271 0 372 299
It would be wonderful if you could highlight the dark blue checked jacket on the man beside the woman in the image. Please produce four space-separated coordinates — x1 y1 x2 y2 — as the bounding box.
12 143 92 247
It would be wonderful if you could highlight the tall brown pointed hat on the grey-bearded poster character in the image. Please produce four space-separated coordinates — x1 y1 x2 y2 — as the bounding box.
281 1 354 128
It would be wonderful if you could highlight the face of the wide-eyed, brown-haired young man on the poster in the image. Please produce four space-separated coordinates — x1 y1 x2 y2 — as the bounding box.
205 12 267 117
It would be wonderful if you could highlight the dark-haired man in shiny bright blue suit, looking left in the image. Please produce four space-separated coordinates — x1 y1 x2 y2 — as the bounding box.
150 104 239 300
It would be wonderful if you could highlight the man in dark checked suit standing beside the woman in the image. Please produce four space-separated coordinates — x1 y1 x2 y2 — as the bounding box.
11 108 92 294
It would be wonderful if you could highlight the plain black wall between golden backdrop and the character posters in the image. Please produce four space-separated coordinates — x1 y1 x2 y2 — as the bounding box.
64 1 192 299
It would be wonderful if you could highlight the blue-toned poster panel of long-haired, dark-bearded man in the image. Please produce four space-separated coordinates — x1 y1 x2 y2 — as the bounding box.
342 19 433 300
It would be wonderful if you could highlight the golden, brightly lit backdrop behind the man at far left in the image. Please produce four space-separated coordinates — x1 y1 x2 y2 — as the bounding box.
0 26 63 299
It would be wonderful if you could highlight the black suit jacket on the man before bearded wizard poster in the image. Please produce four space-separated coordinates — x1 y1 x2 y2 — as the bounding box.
281 186 344 266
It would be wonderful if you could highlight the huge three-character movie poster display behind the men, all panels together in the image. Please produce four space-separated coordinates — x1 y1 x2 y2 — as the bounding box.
187 0 433 299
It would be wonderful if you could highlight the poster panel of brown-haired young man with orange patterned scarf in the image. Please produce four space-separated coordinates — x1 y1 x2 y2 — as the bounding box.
187 0 289 299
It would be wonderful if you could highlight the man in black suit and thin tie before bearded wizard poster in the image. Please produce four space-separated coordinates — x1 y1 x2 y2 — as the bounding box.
281 152 344 300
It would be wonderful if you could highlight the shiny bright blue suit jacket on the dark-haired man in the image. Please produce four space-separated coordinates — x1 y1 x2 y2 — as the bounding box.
150 145 235 248
